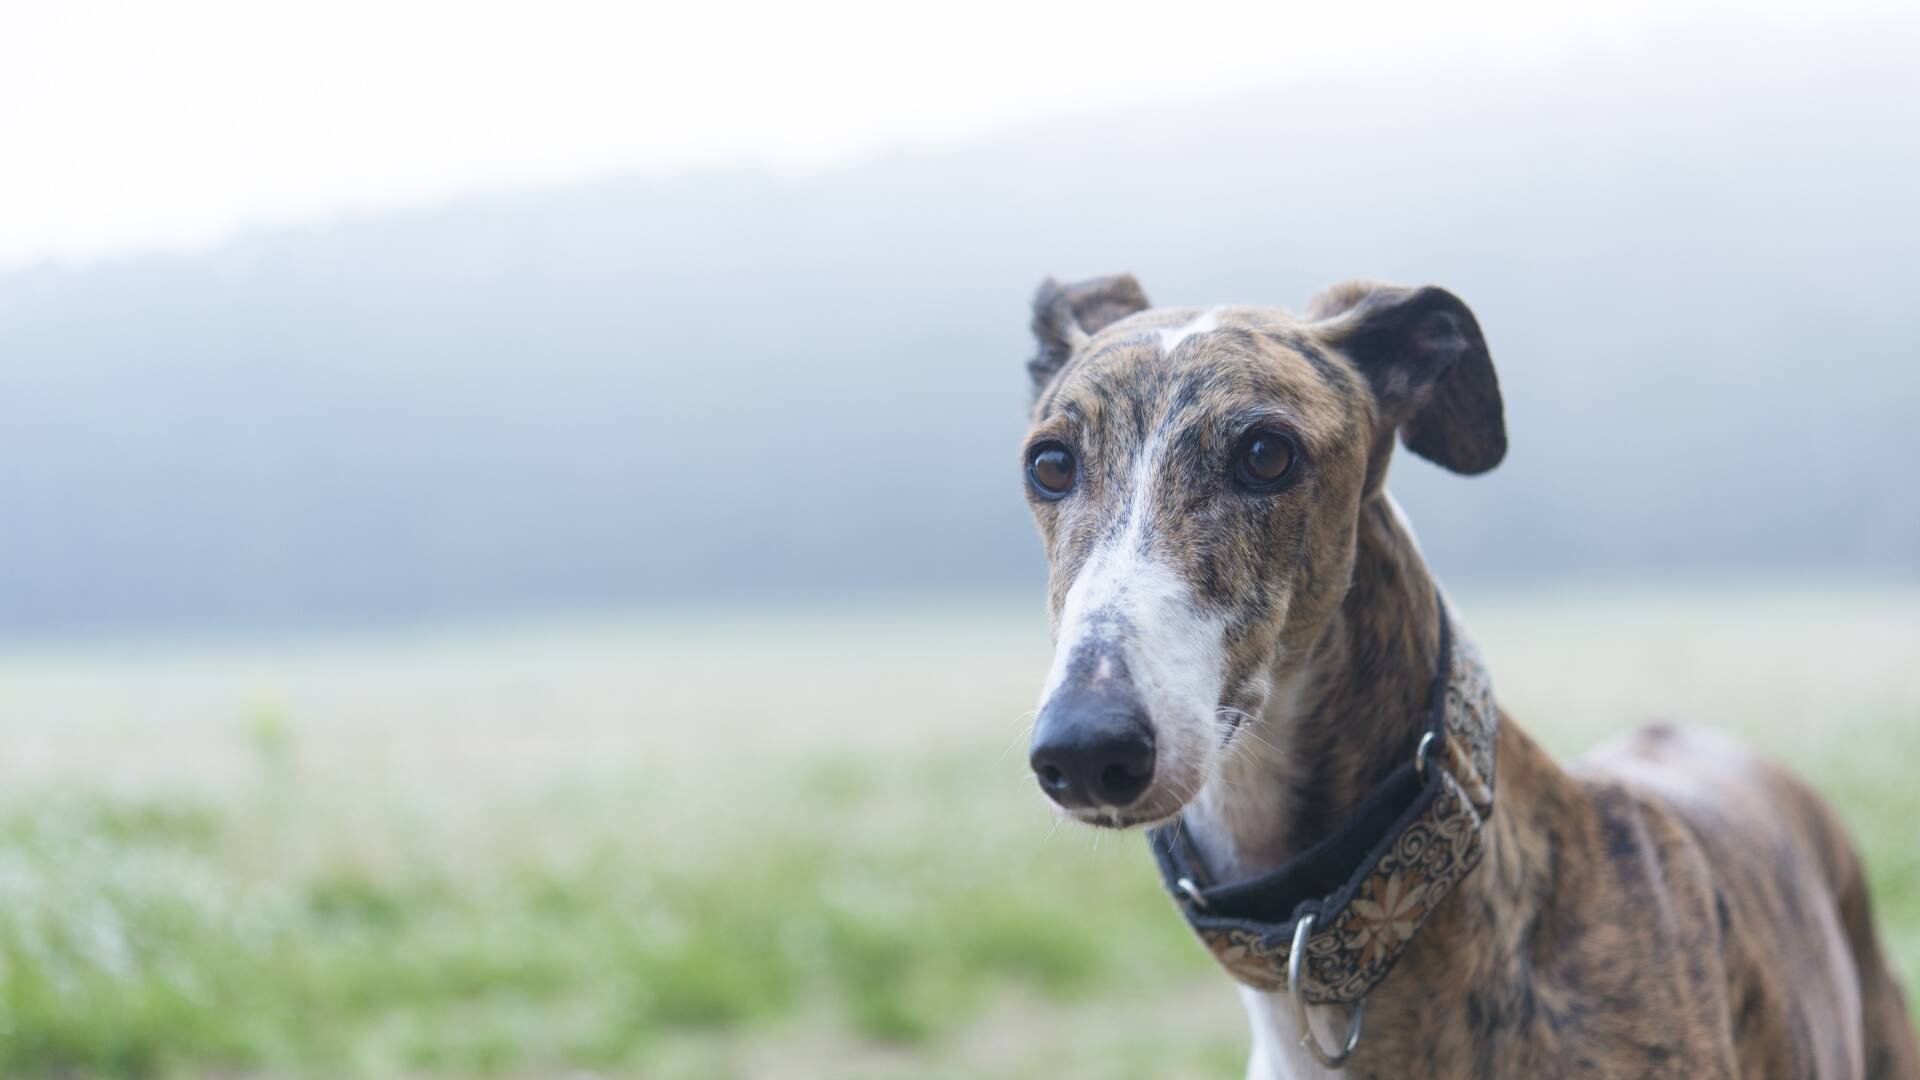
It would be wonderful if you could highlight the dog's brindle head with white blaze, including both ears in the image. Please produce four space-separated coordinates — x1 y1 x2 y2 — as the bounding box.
1021 275 1507 826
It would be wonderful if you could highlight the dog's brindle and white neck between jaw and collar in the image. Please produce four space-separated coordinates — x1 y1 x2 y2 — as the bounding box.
1187 492 1440 880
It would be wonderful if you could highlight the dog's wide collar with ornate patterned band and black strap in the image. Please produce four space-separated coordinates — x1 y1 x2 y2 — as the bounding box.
1148 601 1500 1005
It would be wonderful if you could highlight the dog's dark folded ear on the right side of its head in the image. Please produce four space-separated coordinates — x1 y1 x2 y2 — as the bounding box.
1308 281 1507 475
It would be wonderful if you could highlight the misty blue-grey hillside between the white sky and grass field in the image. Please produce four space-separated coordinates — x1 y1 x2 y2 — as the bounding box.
0 17 1920 638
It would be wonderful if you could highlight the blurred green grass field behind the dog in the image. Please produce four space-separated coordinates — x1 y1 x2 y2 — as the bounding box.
0 586 1920 1078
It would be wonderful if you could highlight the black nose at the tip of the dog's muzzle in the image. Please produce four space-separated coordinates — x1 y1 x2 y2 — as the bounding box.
1029 688 1154 807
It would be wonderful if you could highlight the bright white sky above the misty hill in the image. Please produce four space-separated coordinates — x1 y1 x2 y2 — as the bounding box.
0 0 1901 267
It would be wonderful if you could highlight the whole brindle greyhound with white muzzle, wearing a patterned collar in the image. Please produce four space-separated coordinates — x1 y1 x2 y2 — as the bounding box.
1021 275 1920 1078
